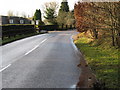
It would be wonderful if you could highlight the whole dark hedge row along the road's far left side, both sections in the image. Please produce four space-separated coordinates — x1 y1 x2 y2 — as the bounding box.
0 24 74 39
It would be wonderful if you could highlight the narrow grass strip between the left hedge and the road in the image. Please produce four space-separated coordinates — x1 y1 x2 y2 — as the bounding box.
0 33 42 45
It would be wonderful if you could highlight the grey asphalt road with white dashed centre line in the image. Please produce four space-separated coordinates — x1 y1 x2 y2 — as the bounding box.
0 31 80 88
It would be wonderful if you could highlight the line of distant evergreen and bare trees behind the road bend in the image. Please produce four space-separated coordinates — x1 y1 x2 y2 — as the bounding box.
33 2 75 27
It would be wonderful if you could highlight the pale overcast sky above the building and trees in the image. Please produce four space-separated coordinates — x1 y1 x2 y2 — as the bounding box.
0 0 78 16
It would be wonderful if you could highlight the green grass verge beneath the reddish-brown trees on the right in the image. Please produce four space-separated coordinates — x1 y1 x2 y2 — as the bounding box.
75 37 120 88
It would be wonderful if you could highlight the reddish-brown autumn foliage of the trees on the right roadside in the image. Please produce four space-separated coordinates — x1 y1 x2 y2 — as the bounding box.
74 2 120 47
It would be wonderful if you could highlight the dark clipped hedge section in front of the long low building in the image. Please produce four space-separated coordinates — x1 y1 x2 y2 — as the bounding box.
0 24 35 38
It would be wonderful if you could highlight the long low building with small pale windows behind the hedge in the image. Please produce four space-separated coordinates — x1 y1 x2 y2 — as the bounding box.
0 16 31 25
